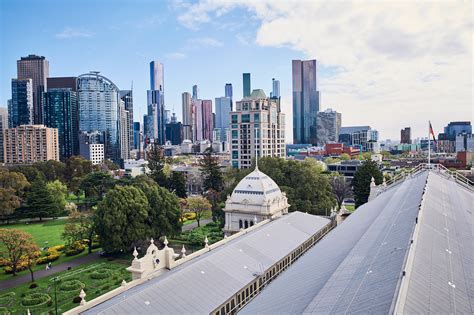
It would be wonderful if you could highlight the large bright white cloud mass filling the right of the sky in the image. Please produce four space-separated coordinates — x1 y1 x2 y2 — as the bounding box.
178 0 474 138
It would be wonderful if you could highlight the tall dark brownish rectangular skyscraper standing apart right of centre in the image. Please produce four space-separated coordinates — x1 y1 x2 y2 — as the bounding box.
292 59 320 144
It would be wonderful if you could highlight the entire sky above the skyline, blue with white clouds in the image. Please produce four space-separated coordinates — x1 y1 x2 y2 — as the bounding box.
0 0 473 140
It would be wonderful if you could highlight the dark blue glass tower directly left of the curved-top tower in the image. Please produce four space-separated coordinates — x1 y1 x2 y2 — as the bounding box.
43 88 79 161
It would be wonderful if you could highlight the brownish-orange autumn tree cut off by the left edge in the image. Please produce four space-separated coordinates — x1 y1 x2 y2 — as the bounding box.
0 170 29 219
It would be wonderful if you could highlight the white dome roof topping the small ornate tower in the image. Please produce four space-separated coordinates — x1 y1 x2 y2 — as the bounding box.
230 168 283 206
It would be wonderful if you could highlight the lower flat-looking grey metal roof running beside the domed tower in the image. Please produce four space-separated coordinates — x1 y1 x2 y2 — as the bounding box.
83 212 329 314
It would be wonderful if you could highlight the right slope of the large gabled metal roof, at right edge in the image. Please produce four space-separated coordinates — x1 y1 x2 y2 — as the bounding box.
400 173 474 314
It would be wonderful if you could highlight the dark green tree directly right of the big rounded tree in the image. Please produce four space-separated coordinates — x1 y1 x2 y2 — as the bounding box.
133 177 181 239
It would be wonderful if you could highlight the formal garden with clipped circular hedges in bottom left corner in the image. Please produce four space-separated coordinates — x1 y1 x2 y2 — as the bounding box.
0 259 131 314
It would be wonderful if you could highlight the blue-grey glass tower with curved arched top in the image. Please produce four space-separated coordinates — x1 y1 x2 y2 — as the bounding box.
77 72 121 163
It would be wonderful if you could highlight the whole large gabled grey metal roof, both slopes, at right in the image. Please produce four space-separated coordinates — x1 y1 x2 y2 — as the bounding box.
241 171 474 314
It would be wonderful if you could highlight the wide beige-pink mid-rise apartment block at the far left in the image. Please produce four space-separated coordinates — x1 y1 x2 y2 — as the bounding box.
4 125 59 164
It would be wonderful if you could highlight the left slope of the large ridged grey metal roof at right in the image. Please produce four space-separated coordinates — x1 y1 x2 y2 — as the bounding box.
241 172 428 314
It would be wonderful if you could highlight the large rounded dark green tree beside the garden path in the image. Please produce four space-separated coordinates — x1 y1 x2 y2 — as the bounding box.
94 186 151 253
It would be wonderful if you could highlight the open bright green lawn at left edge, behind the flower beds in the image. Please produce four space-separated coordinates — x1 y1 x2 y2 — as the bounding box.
0 219 66 247
